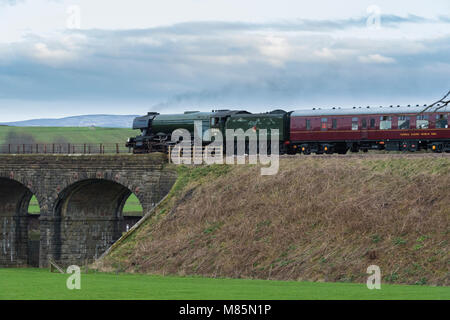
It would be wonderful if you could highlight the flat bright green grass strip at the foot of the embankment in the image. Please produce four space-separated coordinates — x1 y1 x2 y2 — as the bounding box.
0 269 450 300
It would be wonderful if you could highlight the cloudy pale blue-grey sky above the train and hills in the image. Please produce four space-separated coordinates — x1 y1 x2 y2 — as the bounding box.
0 0 450 122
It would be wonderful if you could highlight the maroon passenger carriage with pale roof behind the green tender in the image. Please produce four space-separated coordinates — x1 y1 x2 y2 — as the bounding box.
290 106 450 154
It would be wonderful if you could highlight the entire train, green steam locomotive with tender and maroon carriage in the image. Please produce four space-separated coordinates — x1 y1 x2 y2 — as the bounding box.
126 105 450 154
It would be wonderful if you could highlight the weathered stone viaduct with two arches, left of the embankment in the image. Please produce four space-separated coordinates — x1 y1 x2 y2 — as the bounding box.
0 153 176 267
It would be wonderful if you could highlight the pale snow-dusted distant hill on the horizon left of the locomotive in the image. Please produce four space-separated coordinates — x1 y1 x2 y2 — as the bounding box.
0 114 137 128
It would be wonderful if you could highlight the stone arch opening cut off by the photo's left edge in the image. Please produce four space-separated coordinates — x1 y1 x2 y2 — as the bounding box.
0 177 41 266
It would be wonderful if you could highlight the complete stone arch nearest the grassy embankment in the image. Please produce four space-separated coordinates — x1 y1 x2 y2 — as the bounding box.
51 178 142 266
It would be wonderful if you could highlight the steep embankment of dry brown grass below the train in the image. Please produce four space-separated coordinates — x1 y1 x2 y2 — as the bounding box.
97 156 450 285
